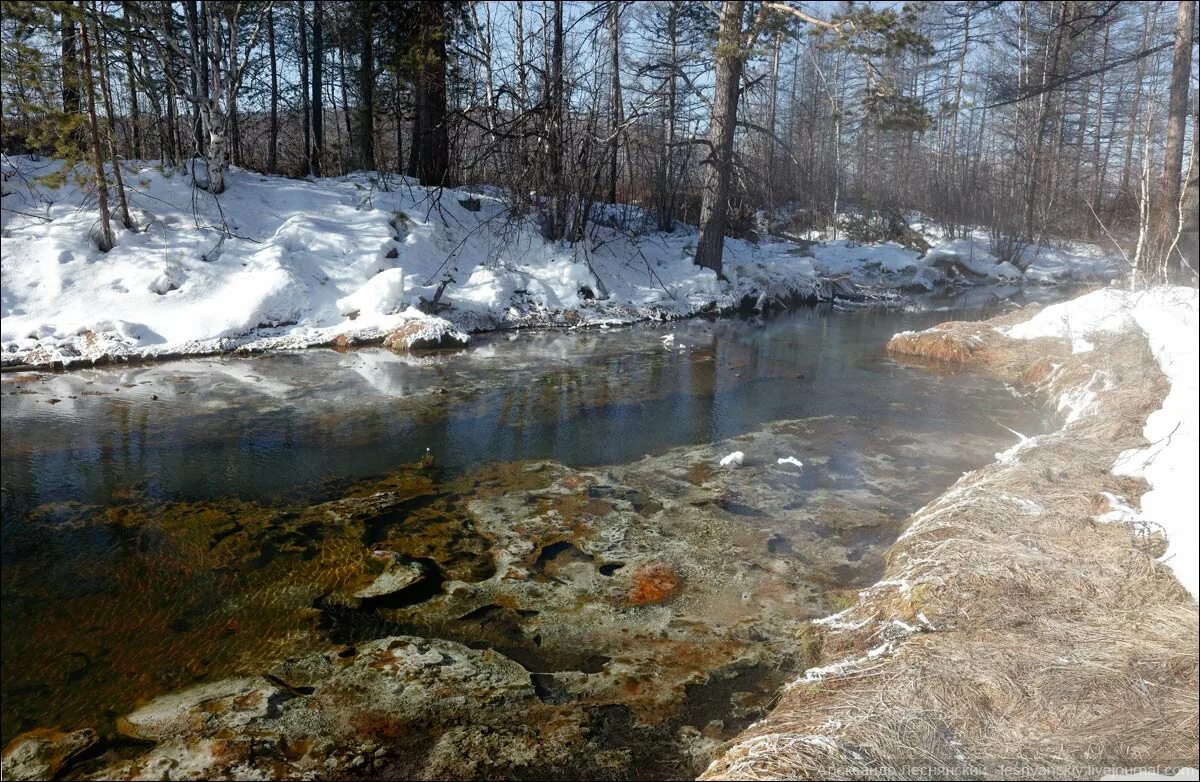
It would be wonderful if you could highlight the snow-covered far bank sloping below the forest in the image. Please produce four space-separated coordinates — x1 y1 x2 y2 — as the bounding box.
0 157 1121 365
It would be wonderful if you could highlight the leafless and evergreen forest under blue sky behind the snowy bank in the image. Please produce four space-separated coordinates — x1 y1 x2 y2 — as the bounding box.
0 0 1198 279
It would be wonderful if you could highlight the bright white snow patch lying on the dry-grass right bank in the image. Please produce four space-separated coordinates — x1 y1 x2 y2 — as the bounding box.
1007 287 1200 596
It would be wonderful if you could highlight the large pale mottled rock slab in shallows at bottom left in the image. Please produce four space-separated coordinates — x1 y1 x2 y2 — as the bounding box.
96 637 538 780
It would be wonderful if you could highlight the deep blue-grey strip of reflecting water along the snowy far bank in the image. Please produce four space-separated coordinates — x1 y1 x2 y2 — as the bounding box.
2 302 1046 510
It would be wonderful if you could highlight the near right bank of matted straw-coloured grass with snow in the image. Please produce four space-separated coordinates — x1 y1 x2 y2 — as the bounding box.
701 288 1198 780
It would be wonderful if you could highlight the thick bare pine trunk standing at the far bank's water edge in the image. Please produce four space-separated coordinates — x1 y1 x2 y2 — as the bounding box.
696 0 745 277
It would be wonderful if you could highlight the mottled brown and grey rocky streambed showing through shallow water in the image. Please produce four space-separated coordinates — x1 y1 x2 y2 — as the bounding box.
5 416 1012 780
